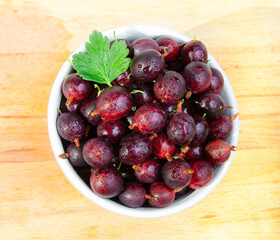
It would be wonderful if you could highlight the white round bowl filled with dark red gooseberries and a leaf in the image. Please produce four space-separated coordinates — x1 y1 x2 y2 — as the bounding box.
48 24 239 218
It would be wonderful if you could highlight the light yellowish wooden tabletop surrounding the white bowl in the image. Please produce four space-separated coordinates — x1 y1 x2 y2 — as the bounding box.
0 0 280 240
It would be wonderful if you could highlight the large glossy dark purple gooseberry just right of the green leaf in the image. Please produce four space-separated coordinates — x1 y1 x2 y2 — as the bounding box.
130 49 165 82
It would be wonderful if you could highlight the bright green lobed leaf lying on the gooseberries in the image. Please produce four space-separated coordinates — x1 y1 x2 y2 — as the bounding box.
73 30 131 86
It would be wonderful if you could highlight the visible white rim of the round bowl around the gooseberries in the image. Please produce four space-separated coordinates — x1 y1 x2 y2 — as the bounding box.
48 24 239 218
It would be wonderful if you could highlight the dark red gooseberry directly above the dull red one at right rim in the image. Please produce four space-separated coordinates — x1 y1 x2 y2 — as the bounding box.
209 115 232 139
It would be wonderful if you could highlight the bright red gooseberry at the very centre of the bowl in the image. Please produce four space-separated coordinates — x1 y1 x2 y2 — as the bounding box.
134 103 168 134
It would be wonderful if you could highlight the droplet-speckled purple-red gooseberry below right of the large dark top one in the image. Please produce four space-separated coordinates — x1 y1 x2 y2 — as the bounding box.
154 71 186 104
